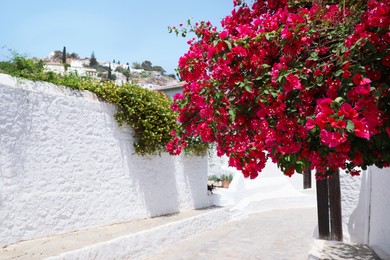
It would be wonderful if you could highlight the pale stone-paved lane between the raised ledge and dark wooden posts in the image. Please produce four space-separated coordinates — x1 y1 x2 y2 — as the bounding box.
146 207 317 260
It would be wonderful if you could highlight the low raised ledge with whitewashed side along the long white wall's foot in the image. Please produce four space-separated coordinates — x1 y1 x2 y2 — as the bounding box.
0 207 230 260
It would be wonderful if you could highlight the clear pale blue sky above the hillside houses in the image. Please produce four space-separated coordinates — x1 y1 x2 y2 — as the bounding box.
0 0 233 73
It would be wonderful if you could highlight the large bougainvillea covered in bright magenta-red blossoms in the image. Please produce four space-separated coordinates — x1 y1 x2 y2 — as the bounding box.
167 0 390 178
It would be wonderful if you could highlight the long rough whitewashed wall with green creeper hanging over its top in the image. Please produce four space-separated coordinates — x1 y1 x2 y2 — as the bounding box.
0 74 212 247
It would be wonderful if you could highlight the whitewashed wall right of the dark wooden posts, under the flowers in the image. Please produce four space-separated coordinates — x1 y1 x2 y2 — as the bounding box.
341 167 390 259
